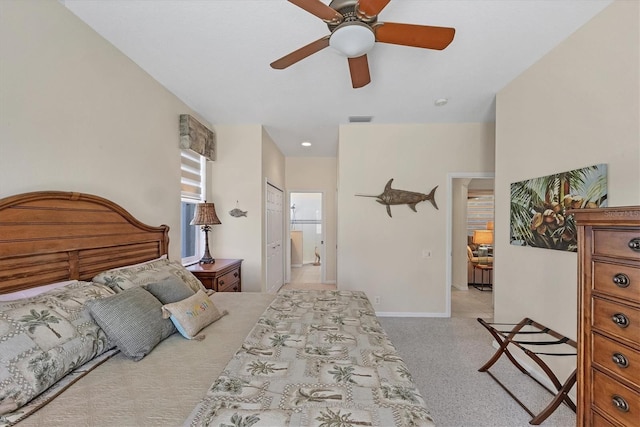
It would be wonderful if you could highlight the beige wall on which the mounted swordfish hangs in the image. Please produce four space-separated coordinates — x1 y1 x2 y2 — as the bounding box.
338 123 494 316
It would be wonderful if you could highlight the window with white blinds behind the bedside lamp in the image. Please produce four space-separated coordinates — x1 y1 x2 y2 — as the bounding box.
180 150 206 264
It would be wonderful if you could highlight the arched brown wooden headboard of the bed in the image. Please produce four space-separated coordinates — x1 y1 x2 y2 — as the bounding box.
0 191 169 293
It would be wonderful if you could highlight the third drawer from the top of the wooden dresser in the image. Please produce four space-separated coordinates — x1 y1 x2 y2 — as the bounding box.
593 298 640 343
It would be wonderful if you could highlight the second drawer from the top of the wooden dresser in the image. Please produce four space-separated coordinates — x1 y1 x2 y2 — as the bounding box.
593 262 640 302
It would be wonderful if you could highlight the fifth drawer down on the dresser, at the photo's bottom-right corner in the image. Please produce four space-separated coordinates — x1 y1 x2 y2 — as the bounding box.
591 369 640 426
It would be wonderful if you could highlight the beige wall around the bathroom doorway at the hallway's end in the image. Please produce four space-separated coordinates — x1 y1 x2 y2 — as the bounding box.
285 157 338 283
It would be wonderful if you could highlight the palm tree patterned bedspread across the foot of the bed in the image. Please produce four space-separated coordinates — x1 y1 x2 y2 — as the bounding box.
185 290 434 427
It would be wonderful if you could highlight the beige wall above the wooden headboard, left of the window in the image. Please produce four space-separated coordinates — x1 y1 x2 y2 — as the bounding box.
0 1 206 259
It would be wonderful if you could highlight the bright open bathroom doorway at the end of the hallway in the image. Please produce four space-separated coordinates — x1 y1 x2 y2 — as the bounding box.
288 191 325 284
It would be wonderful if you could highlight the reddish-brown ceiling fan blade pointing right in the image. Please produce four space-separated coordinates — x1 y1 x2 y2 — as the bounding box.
374 22 456 50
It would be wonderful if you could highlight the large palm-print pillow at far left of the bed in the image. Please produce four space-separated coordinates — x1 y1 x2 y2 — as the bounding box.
0 281 114 415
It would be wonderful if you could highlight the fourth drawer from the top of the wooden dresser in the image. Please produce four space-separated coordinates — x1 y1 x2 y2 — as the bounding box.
592 334 640 388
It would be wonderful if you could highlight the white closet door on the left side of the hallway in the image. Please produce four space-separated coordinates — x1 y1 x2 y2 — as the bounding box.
266 183 284 293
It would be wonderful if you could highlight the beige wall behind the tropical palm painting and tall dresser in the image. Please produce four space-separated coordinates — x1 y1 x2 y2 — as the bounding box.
494 1 640 380
